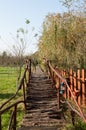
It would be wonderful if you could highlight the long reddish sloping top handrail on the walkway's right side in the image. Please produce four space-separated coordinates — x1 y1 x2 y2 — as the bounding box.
47 61 86 122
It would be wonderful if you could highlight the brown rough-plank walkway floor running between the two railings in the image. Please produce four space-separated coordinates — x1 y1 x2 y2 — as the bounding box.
18 68 65 130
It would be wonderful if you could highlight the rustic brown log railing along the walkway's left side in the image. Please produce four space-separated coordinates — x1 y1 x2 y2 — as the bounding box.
0 60 31 130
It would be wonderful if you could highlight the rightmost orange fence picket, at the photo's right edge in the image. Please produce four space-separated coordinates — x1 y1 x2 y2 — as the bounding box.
82 69 85 105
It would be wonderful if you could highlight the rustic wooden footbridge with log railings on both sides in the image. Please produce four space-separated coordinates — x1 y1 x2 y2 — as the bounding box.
0 60 86 130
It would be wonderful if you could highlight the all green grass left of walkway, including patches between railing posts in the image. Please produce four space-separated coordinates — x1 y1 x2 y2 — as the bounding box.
0 67 23 130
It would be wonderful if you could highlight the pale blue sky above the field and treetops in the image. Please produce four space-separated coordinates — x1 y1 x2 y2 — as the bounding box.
0 0 64 54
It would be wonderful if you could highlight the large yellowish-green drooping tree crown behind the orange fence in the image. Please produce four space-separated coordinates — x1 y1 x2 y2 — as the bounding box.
38 13 86 68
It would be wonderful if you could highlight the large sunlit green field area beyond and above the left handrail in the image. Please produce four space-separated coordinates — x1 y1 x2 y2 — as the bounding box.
0 67 17 102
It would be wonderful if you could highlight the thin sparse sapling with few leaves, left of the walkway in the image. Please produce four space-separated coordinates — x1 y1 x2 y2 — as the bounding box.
12 19 30 80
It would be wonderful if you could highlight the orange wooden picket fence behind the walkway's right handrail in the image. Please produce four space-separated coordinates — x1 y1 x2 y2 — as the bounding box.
62 69 86 106
